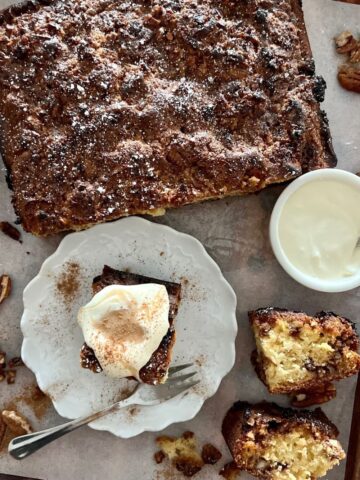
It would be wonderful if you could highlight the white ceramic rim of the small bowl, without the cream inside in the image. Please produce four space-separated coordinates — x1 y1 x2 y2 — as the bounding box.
270 169 360 293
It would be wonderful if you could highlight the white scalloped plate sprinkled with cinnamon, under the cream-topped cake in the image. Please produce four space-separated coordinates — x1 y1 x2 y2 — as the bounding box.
21 217 237 438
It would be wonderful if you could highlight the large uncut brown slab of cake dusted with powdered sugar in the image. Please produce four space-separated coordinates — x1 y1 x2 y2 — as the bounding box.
0 0 336 235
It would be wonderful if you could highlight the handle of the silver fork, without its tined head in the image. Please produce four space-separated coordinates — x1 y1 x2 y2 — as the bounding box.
8 400 132 460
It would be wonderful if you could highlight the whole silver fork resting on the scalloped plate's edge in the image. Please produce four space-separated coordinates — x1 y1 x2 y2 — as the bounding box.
8 363 199 460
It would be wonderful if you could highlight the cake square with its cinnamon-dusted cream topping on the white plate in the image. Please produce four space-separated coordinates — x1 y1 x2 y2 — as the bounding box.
79 266 181 384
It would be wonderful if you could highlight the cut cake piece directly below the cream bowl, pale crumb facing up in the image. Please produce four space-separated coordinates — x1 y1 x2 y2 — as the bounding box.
249 307 360 403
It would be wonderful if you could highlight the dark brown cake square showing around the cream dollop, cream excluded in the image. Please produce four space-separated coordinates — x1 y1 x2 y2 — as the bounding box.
80 265 181 385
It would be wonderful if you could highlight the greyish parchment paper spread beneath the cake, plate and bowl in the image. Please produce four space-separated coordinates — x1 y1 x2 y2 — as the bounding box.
0 0 360 480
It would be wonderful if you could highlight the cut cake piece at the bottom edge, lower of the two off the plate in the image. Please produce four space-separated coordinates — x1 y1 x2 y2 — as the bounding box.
222 402 345 480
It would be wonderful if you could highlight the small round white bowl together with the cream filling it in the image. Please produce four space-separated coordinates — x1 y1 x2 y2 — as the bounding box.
270 169 360 292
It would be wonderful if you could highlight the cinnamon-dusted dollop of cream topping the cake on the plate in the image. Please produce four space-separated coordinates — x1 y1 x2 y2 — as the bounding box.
78 283 170 380
